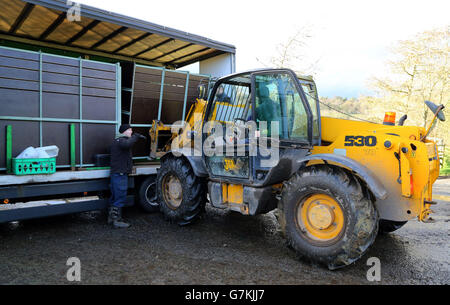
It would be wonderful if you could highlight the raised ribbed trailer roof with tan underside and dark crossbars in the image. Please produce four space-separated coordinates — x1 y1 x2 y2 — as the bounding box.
0 0 236 68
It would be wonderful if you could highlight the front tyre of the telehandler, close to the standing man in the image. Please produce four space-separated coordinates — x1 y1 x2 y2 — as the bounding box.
157 157 207 226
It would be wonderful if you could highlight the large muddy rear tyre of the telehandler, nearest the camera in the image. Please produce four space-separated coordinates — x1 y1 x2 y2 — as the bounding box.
279 165 379 270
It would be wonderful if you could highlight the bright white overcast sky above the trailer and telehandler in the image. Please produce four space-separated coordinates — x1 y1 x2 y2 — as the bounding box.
76 0 450 98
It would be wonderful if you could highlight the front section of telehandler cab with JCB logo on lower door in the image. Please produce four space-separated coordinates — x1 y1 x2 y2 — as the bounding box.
203 73 253 184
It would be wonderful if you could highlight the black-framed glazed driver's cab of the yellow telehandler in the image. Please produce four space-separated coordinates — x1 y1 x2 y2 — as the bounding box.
203 69 312 186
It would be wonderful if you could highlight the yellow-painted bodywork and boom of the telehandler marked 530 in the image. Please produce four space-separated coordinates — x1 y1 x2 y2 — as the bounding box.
150 94 439 221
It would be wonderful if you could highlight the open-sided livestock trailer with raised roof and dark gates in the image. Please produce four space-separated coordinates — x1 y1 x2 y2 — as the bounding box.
0 0 235 223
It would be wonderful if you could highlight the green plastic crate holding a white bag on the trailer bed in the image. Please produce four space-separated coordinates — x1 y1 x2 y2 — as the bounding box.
12 158 56 176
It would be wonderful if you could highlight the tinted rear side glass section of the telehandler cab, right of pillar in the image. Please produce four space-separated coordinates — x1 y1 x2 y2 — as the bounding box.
251 69 313 186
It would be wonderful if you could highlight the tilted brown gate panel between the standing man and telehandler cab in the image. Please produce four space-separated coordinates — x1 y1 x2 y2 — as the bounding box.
122 65 212 159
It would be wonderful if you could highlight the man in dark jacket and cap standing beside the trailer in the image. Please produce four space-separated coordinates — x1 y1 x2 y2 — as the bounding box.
108 124 145 228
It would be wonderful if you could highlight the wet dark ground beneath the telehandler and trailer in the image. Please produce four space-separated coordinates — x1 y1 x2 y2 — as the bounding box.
0 179 450 285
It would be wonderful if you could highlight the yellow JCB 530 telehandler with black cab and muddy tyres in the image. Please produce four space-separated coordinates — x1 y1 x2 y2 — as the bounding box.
150 69 445 269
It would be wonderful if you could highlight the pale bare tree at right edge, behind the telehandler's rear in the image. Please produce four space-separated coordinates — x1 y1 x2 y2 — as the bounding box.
371 27 450 143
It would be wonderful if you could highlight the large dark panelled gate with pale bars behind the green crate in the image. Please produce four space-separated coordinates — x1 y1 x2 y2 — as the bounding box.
0 47 121 170
